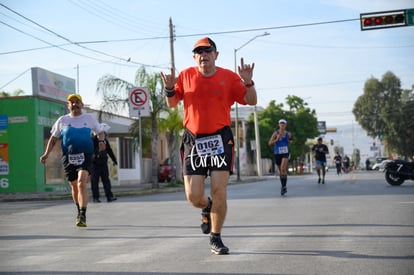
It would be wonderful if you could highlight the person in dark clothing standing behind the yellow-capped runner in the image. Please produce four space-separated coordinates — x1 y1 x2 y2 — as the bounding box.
91 123 118 202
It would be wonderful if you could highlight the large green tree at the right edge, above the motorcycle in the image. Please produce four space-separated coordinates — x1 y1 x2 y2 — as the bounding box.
352 71 414 157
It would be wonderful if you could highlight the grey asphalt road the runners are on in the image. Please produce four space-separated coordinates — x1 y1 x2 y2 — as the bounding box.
0 172 414 275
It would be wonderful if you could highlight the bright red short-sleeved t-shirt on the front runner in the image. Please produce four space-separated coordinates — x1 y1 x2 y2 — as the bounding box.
174 67 246 134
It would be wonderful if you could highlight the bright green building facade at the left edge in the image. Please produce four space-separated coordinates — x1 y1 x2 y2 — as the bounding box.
0 96 68 193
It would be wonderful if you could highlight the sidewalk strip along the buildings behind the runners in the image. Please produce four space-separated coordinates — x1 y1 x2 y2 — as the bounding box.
0 175 266 202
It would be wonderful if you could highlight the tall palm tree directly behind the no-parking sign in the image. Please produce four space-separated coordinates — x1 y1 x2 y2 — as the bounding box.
97 67 168 188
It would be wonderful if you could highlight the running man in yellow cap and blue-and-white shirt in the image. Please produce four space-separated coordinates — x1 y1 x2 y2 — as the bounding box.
40 94 106 227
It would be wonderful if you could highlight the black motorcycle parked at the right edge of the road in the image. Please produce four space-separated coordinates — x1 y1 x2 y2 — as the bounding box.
384 159 414 186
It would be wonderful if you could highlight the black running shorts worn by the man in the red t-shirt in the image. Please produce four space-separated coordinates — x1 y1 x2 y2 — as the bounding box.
180 126 234 176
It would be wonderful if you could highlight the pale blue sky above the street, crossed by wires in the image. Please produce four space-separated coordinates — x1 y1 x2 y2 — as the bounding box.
0 0 414 158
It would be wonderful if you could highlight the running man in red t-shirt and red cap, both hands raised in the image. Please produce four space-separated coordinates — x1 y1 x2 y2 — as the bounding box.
161 37 257 255
